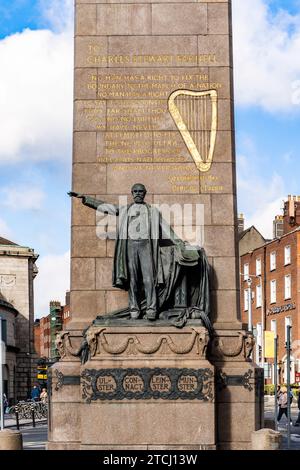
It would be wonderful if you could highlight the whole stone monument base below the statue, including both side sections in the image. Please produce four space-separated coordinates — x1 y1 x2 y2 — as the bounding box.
48 320 263 450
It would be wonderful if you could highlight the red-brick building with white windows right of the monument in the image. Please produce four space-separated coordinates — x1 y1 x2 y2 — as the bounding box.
240 196 300 382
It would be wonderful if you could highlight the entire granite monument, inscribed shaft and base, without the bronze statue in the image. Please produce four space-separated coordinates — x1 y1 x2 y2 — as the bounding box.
48 0 263 449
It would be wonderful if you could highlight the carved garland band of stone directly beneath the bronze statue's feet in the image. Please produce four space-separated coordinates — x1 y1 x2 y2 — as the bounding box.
85 326 209 359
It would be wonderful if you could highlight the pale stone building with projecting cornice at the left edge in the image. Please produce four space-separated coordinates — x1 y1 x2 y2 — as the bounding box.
0 237 38 402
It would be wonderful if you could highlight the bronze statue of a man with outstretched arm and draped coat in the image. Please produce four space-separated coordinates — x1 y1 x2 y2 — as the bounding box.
69 183 209 321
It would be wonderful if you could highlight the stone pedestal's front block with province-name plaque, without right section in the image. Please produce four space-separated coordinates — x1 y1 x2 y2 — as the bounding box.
48 322 216 450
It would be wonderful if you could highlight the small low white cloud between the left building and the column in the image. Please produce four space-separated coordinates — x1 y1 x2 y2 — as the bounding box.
34 251 70 318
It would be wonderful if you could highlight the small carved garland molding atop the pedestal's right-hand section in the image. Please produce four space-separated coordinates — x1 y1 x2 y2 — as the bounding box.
209 331 255 360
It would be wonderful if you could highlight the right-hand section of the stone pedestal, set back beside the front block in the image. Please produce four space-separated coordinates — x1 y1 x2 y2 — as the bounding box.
208 324 264 450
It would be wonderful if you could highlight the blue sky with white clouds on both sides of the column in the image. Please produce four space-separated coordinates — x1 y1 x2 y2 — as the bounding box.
0 0 300 316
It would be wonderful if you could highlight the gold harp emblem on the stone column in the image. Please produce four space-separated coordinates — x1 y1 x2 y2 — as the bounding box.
168 90 218 172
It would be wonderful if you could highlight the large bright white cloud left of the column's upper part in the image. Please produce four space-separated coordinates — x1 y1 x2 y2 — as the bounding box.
0 25 73 163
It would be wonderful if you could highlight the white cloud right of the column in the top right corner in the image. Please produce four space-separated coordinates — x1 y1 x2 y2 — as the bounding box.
233 0 300 112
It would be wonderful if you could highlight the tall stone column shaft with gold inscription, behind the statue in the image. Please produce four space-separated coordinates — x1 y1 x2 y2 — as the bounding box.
71 0 241 327
